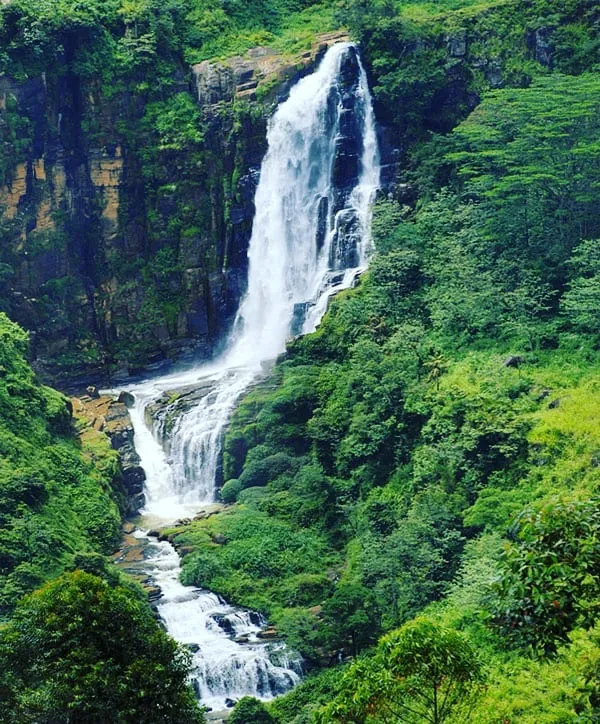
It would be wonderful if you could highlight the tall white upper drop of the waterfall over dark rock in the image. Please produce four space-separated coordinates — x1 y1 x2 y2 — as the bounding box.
225 43 379 367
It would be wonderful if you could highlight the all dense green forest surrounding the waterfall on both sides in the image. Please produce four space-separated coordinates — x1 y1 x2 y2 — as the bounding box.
0 0 600 724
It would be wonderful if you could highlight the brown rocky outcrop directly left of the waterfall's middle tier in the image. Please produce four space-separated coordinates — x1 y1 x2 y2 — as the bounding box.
72 395 146 517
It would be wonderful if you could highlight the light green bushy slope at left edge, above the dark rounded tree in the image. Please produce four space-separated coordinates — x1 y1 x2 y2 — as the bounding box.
0 314 121 615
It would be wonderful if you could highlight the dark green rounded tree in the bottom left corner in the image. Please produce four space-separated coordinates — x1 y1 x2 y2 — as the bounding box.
0 571 202 724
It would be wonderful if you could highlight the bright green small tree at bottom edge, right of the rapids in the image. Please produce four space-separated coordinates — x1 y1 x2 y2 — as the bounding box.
318 617 483 724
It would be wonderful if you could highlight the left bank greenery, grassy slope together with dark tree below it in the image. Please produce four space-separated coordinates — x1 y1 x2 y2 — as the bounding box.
0 314 202 724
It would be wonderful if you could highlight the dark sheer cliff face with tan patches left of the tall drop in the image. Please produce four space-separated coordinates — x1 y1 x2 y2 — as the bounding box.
0 34 341 385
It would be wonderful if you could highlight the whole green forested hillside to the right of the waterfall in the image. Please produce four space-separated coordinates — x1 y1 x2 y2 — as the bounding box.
163 2 600 724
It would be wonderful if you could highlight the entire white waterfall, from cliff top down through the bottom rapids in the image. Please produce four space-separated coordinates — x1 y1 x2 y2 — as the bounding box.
124 43 379 709
